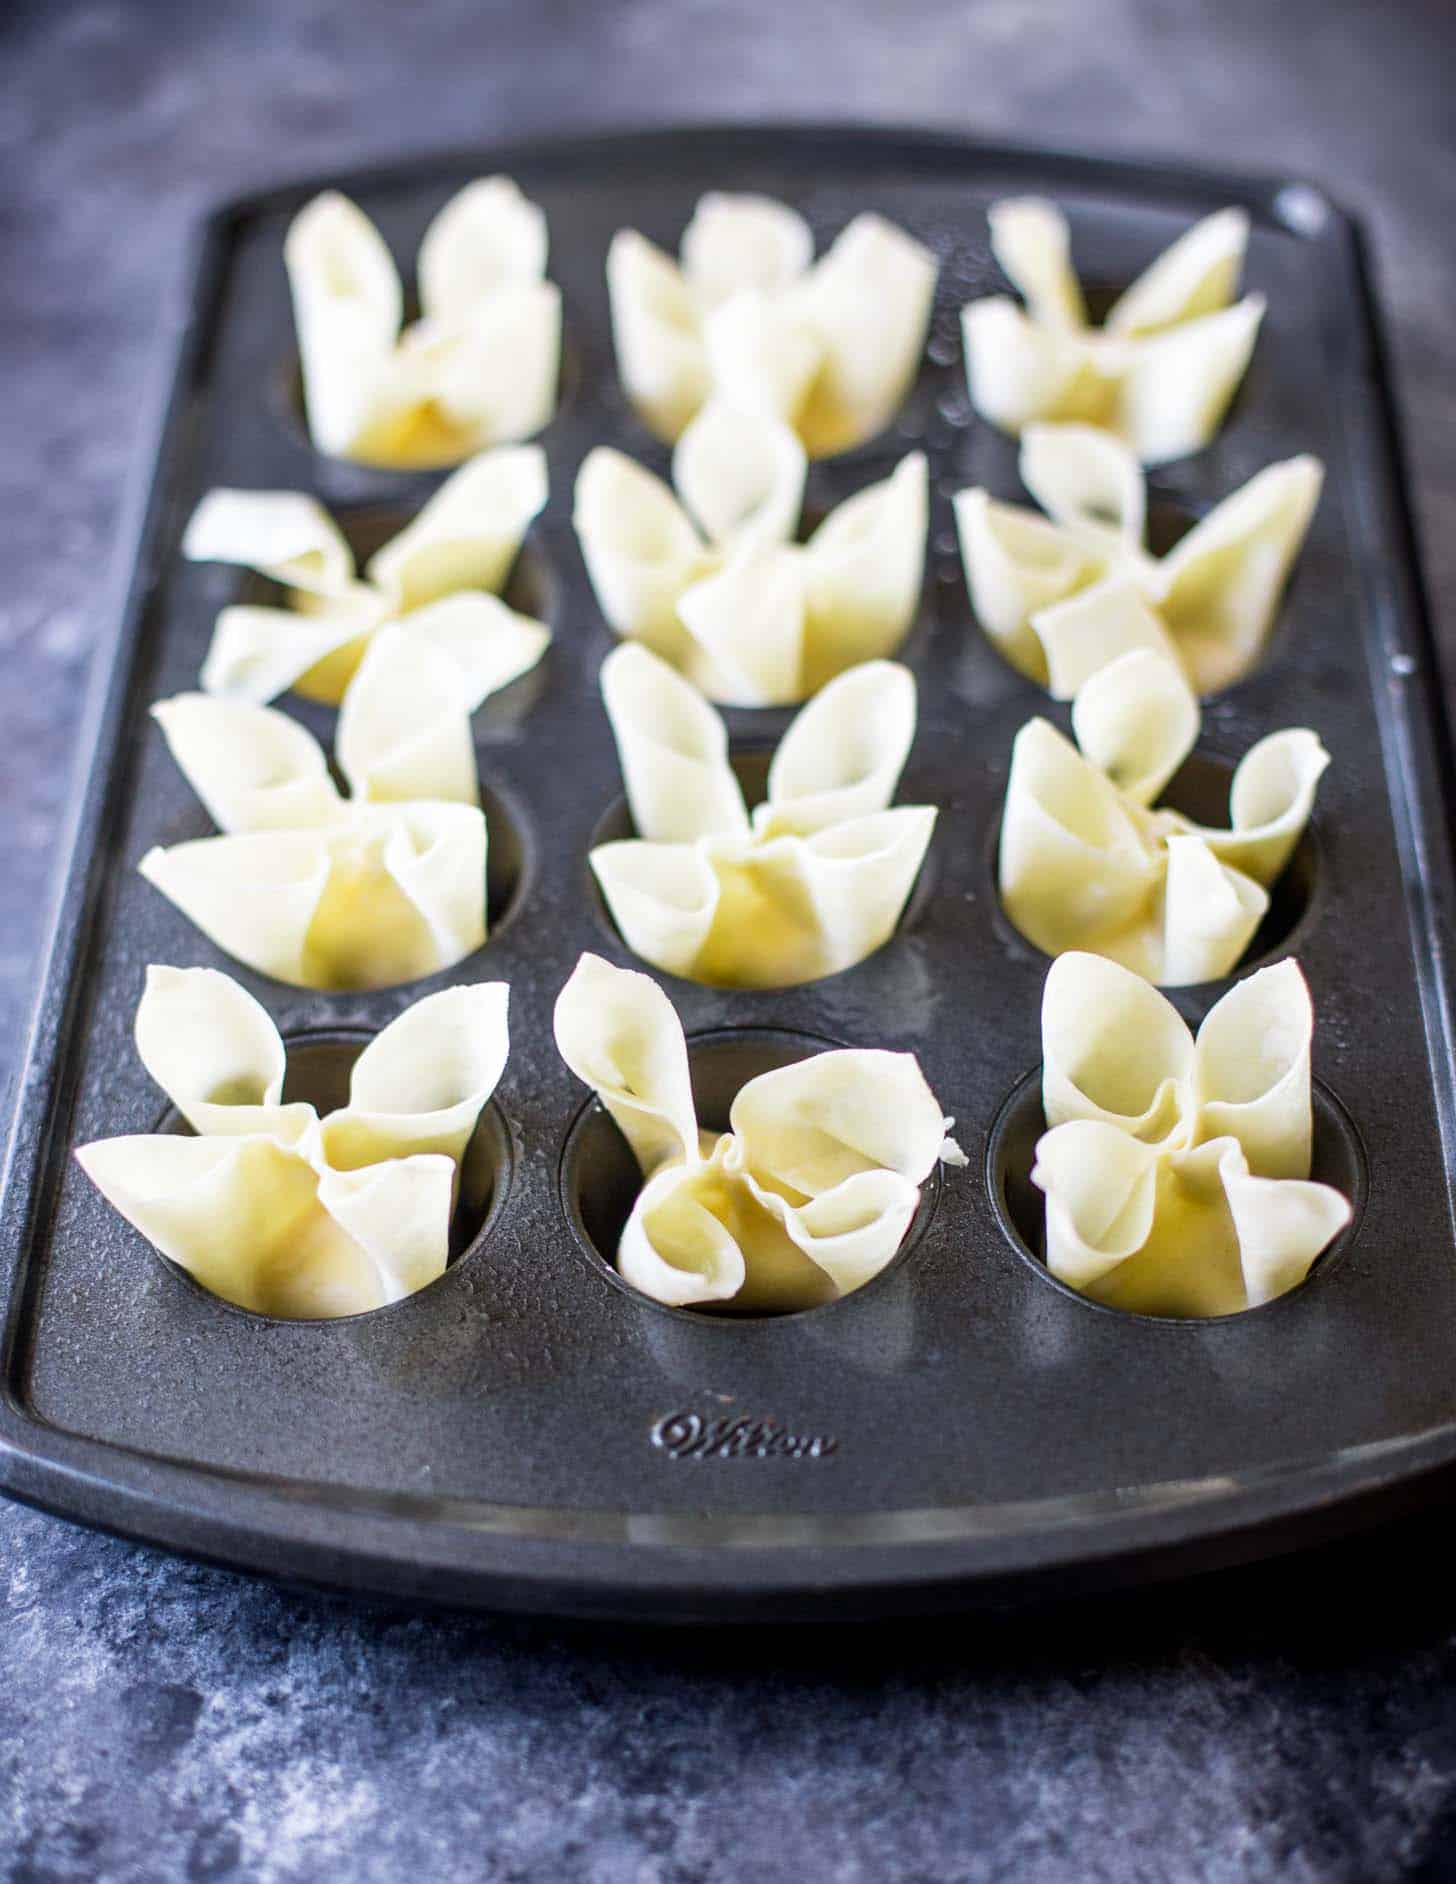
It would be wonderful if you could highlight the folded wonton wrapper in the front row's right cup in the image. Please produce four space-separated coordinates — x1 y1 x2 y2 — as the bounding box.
1032 953 1351 1315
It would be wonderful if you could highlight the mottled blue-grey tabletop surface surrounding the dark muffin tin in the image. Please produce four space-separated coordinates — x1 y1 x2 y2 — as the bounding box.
0 0 1456 1884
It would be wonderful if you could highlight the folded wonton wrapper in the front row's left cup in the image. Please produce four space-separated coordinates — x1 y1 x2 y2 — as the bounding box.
75 966 510 1321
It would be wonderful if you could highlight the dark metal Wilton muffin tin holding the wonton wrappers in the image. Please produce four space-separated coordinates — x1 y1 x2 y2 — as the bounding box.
0 128 1456 1618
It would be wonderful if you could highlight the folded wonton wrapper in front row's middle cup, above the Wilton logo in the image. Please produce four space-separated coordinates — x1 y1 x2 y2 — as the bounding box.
556 955 964 1311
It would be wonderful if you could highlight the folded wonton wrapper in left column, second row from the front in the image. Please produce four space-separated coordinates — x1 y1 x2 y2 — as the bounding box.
139 625 486 989
